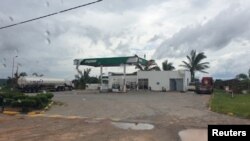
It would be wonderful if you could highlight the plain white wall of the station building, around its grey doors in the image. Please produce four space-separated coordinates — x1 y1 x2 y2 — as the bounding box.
137 70 190 91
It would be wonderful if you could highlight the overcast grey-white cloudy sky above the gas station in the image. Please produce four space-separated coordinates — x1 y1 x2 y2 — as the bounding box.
0 0 250 79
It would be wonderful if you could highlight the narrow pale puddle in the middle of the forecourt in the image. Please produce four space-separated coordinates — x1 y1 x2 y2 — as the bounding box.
112 122 154 130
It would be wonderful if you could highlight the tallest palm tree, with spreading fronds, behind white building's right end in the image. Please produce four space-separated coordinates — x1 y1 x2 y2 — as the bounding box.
180 50 209 82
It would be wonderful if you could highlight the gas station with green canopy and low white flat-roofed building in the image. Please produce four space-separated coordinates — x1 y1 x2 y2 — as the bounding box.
74 55 191 92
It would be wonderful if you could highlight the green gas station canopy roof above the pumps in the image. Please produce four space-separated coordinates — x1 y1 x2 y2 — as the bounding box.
74 55 148 67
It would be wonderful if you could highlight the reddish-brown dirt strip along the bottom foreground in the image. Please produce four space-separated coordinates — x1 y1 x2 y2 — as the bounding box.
0 115 181 141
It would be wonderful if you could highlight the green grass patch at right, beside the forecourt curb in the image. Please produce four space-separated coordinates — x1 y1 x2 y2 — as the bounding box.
210 90 250 118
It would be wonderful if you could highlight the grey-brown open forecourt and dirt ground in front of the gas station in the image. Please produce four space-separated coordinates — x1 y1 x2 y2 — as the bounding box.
0 91 250 141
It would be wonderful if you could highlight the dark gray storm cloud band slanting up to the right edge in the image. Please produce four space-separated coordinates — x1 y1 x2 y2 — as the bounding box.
154 4 250 59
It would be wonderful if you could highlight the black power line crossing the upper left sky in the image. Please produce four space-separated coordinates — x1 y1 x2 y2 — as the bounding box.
0 0 103 30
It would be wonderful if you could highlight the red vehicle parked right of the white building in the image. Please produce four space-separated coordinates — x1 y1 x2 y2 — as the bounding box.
196 77 214 94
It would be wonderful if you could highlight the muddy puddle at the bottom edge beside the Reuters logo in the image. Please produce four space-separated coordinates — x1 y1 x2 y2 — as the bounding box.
178 129 207 141
